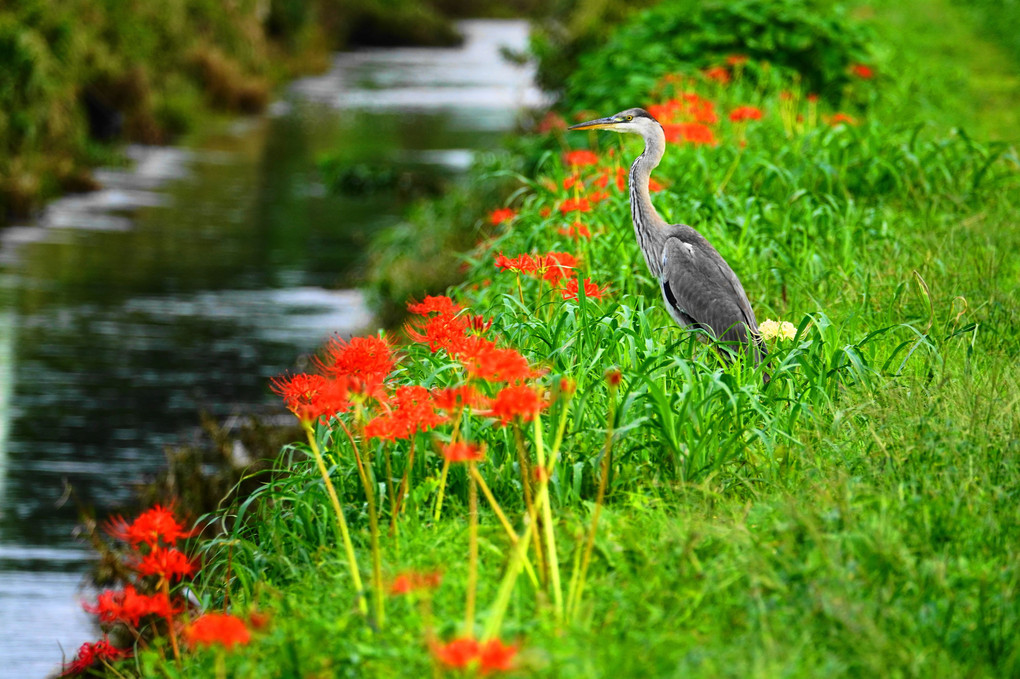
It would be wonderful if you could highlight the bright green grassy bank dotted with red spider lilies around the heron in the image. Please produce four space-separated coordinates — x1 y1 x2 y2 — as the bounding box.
63 0 1020 677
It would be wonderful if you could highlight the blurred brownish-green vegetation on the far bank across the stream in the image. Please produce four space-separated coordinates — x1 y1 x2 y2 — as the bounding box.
0 0 537 224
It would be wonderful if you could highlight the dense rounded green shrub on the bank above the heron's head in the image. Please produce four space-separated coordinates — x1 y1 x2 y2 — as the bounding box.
564 0 869 110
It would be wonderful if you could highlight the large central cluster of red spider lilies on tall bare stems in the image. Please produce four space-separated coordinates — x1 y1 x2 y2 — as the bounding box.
273 287 620 671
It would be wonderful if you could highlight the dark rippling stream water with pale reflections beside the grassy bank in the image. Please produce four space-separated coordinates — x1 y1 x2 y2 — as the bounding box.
0 21 540 679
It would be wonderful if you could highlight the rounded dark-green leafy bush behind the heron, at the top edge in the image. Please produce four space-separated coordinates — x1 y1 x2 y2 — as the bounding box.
531 0 870 110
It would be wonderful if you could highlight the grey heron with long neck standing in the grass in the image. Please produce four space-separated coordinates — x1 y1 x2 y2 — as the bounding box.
570 108 765 363
